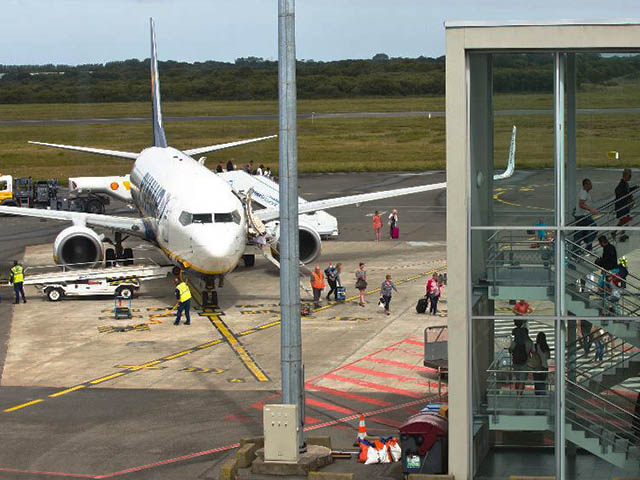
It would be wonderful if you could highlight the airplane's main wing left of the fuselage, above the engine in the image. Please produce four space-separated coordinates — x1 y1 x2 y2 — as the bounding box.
0 206 146 237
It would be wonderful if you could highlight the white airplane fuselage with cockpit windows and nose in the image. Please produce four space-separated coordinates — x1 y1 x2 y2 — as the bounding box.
131 147 247 275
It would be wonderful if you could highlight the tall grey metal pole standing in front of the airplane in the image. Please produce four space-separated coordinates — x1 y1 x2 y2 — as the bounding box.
278 0 305 451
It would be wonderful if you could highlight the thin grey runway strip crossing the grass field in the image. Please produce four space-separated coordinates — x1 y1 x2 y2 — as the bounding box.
0 108 640 126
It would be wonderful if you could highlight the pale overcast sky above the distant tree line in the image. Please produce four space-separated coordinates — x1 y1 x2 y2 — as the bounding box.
0 0 640 64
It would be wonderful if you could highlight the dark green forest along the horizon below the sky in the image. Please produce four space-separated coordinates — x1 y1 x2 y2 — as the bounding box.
0 53 640 103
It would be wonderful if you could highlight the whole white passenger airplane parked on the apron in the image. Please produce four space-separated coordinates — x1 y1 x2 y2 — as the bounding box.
0 19 515 306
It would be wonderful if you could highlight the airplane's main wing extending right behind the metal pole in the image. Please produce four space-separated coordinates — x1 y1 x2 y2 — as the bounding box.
253 182 447 222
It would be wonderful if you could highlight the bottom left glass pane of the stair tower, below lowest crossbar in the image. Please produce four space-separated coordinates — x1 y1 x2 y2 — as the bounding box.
472 318 555 480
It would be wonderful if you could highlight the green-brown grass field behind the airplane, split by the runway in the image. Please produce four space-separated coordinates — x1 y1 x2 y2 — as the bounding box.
0 83 640 180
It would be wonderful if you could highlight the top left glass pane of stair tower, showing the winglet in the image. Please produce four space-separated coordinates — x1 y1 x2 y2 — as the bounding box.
470 53 555 226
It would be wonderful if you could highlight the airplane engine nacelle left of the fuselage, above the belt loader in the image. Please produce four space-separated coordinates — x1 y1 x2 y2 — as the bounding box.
53 225 103 268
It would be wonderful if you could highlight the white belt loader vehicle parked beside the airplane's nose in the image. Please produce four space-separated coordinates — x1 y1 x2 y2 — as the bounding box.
24 260 174 302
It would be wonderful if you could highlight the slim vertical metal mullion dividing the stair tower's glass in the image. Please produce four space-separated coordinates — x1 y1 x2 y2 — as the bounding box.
553 52 567 480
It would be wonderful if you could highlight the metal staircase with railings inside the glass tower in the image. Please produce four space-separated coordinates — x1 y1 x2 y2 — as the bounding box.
475 191 640 472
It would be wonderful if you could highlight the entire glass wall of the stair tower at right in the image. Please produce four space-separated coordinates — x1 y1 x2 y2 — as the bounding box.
467 52 640 480
